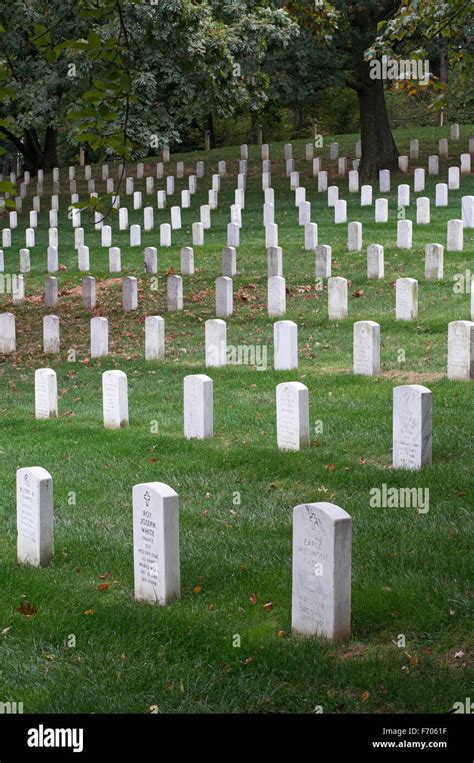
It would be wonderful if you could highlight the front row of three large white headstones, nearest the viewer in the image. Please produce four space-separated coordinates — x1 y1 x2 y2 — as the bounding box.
16 466 352 640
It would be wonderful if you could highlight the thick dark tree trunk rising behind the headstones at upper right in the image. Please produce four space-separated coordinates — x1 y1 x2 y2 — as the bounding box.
357 80 398 181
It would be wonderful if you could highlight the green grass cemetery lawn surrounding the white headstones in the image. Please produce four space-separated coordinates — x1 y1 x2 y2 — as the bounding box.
0 126 474 713
